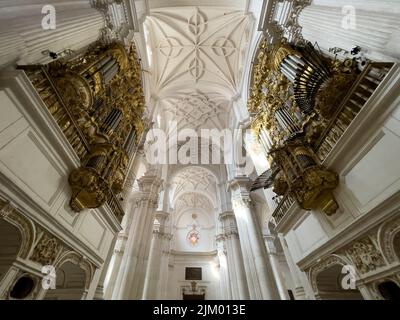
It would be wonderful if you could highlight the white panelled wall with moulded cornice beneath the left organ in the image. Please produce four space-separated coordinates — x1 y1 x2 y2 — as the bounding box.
0 72 118 266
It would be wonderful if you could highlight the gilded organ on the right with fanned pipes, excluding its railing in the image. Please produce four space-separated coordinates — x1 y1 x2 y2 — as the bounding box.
248 41 358 215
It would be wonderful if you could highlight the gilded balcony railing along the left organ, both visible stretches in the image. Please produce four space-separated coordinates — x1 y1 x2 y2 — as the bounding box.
21 66 124 222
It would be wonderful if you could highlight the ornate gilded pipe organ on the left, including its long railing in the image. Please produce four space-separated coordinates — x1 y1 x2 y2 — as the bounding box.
23 42 145 211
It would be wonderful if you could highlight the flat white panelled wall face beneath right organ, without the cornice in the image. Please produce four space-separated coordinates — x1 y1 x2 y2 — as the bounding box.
285 102 400 262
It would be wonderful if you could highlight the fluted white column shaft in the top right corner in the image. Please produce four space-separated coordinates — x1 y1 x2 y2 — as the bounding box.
298 0 400 61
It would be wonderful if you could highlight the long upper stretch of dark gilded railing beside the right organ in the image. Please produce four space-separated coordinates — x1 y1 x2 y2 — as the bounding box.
315 62 393 162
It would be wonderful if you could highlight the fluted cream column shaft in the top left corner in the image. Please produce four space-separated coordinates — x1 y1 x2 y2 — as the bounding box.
0 0 105 67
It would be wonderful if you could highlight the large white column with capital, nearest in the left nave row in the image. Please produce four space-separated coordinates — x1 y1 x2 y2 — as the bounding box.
113 172 161 299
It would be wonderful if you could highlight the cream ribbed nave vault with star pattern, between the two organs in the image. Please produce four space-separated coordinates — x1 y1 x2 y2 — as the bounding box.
144 5 254 131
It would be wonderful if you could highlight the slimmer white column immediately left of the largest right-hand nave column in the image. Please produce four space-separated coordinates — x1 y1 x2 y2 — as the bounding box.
219 211 250 300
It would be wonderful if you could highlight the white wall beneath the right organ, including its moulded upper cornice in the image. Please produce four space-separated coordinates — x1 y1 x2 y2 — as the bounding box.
279 67 400 272
